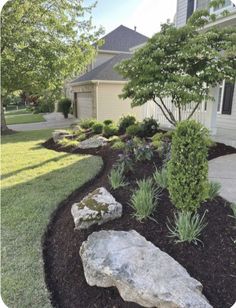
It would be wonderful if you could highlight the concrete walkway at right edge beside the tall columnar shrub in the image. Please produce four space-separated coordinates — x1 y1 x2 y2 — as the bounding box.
209 154 236 203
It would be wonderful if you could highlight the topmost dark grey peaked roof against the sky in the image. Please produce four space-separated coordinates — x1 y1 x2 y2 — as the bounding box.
99 25 148 52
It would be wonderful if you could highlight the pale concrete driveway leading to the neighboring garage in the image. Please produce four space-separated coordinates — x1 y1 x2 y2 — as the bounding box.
8 112 78 131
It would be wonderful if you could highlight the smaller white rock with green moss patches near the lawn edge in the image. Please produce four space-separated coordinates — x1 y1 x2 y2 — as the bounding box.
71 187 122 229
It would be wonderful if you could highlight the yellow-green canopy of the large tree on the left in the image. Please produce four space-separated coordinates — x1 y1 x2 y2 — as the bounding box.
1 0 101 130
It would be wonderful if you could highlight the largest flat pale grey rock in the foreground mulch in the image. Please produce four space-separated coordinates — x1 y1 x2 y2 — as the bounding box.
80 230 212 308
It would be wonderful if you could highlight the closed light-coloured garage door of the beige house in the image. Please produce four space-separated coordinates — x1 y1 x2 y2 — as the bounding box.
77 92 93 119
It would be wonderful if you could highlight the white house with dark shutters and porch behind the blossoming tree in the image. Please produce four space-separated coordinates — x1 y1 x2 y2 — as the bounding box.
145 0 236 147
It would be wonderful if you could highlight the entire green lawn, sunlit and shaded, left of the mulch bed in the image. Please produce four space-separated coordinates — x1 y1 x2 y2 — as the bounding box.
1 130 102 308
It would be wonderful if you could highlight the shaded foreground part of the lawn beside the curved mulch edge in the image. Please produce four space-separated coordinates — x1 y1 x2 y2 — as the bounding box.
1 156 102 307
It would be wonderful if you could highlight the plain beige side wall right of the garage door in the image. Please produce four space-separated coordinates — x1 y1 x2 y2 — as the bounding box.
97 83 143 121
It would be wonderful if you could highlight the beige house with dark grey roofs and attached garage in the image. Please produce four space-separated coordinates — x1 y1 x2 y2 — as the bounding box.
70 25 148 121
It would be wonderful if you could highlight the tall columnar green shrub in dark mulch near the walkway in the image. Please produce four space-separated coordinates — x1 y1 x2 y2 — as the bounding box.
167 120 209 212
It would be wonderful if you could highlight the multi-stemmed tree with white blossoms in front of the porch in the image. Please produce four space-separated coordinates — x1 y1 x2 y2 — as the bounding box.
117 6 236 126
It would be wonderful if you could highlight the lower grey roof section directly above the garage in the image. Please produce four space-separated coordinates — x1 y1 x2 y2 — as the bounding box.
71 54 132 84
